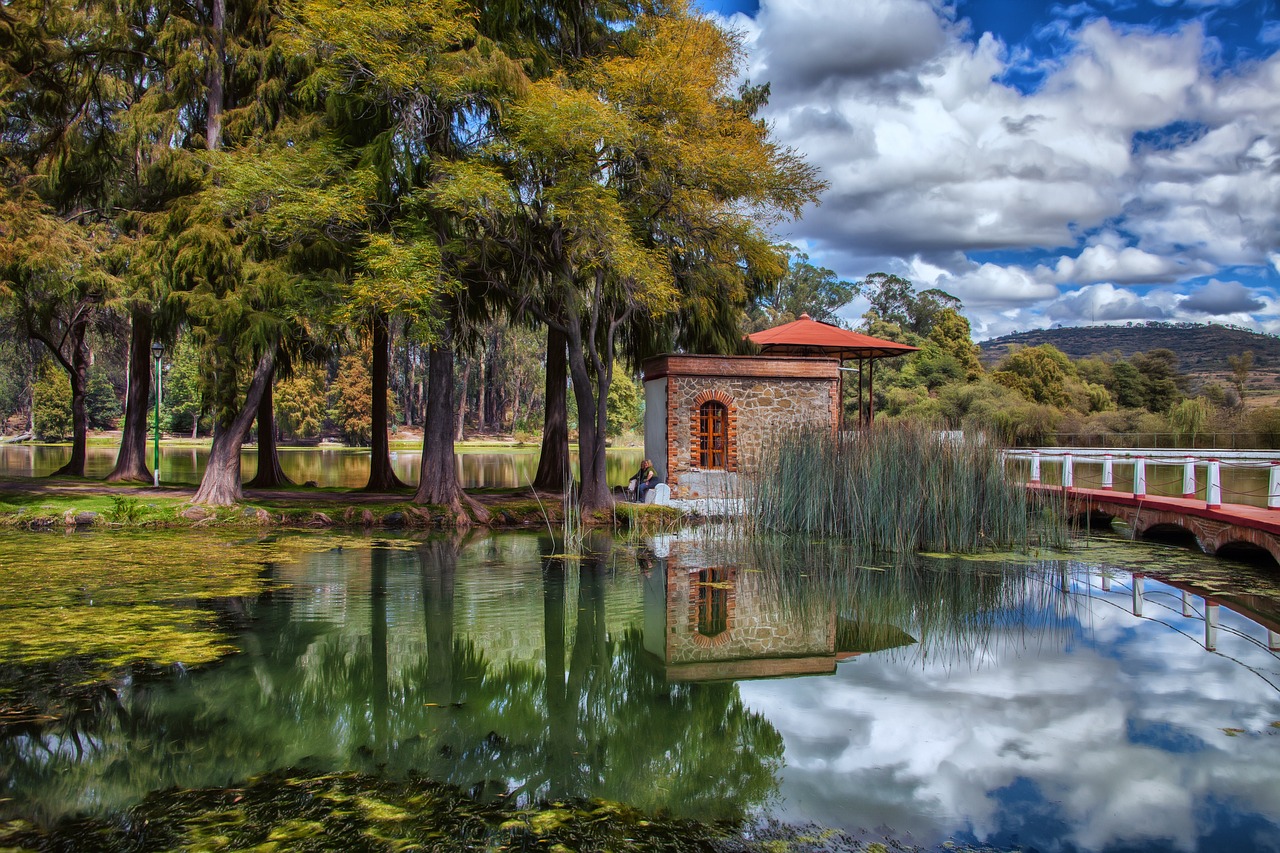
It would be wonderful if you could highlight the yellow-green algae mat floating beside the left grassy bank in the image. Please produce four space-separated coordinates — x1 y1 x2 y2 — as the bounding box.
0 532 412 702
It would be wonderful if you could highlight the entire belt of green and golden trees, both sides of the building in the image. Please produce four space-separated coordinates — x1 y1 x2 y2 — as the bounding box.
0 0 1280 512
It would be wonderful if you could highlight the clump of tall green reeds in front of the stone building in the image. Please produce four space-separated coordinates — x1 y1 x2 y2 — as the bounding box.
744 424 1065 553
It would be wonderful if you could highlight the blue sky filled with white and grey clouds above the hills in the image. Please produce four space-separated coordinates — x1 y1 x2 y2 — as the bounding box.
699 0 1280 341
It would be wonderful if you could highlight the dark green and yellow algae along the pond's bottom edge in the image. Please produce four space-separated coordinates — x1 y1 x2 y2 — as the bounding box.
0 771 993 853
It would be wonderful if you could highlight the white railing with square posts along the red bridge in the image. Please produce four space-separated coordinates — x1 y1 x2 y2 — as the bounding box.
1005 447 1280 510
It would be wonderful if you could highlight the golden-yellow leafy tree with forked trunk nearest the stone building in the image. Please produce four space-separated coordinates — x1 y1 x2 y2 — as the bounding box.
457 6 822 510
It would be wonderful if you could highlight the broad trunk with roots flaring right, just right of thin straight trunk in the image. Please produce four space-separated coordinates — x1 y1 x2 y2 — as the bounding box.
413 335 489 526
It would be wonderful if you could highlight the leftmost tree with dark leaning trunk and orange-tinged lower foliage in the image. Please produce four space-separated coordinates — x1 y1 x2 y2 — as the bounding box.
0 0 122 476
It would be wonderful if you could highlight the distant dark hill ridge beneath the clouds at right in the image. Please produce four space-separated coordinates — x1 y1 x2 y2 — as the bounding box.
978 321 1280 374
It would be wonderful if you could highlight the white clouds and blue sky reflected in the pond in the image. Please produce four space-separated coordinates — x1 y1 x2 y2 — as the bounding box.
740 578 1280 850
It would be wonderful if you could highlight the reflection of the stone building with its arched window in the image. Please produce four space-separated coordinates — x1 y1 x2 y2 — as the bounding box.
644 545 837 681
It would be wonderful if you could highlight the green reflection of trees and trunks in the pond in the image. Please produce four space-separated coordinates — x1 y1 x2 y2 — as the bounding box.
0 539 782 818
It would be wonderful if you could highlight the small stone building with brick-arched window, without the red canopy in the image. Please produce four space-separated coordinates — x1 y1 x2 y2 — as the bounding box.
643 355 840 498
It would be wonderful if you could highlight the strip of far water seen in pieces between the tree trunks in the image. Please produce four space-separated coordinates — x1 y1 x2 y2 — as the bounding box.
0 444 644 489
